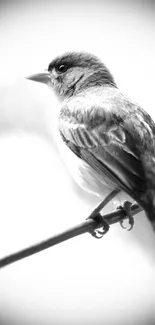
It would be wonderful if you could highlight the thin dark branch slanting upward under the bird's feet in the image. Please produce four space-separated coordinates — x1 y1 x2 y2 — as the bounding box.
0 203 142 268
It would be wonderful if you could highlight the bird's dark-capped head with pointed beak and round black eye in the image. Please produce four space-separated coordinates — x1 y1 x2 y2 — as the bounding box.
27 52 116 100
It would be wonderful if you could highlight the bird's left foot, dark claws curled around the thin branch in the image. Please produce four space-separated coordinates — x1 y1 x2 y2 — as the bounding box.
86 213 110 239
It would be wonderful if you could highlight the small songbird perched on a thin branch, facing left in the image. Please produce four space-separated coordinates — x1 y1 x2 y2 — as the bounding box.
27 52 155 236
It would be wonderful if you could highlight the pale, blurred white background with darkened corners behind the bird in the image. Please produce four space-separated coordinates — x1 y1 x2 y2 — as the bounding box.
0 0 155 325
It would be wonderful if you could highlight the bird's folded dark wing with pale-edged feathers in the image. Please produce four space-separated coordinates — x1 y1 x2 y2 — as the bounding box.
59 111 145 199
